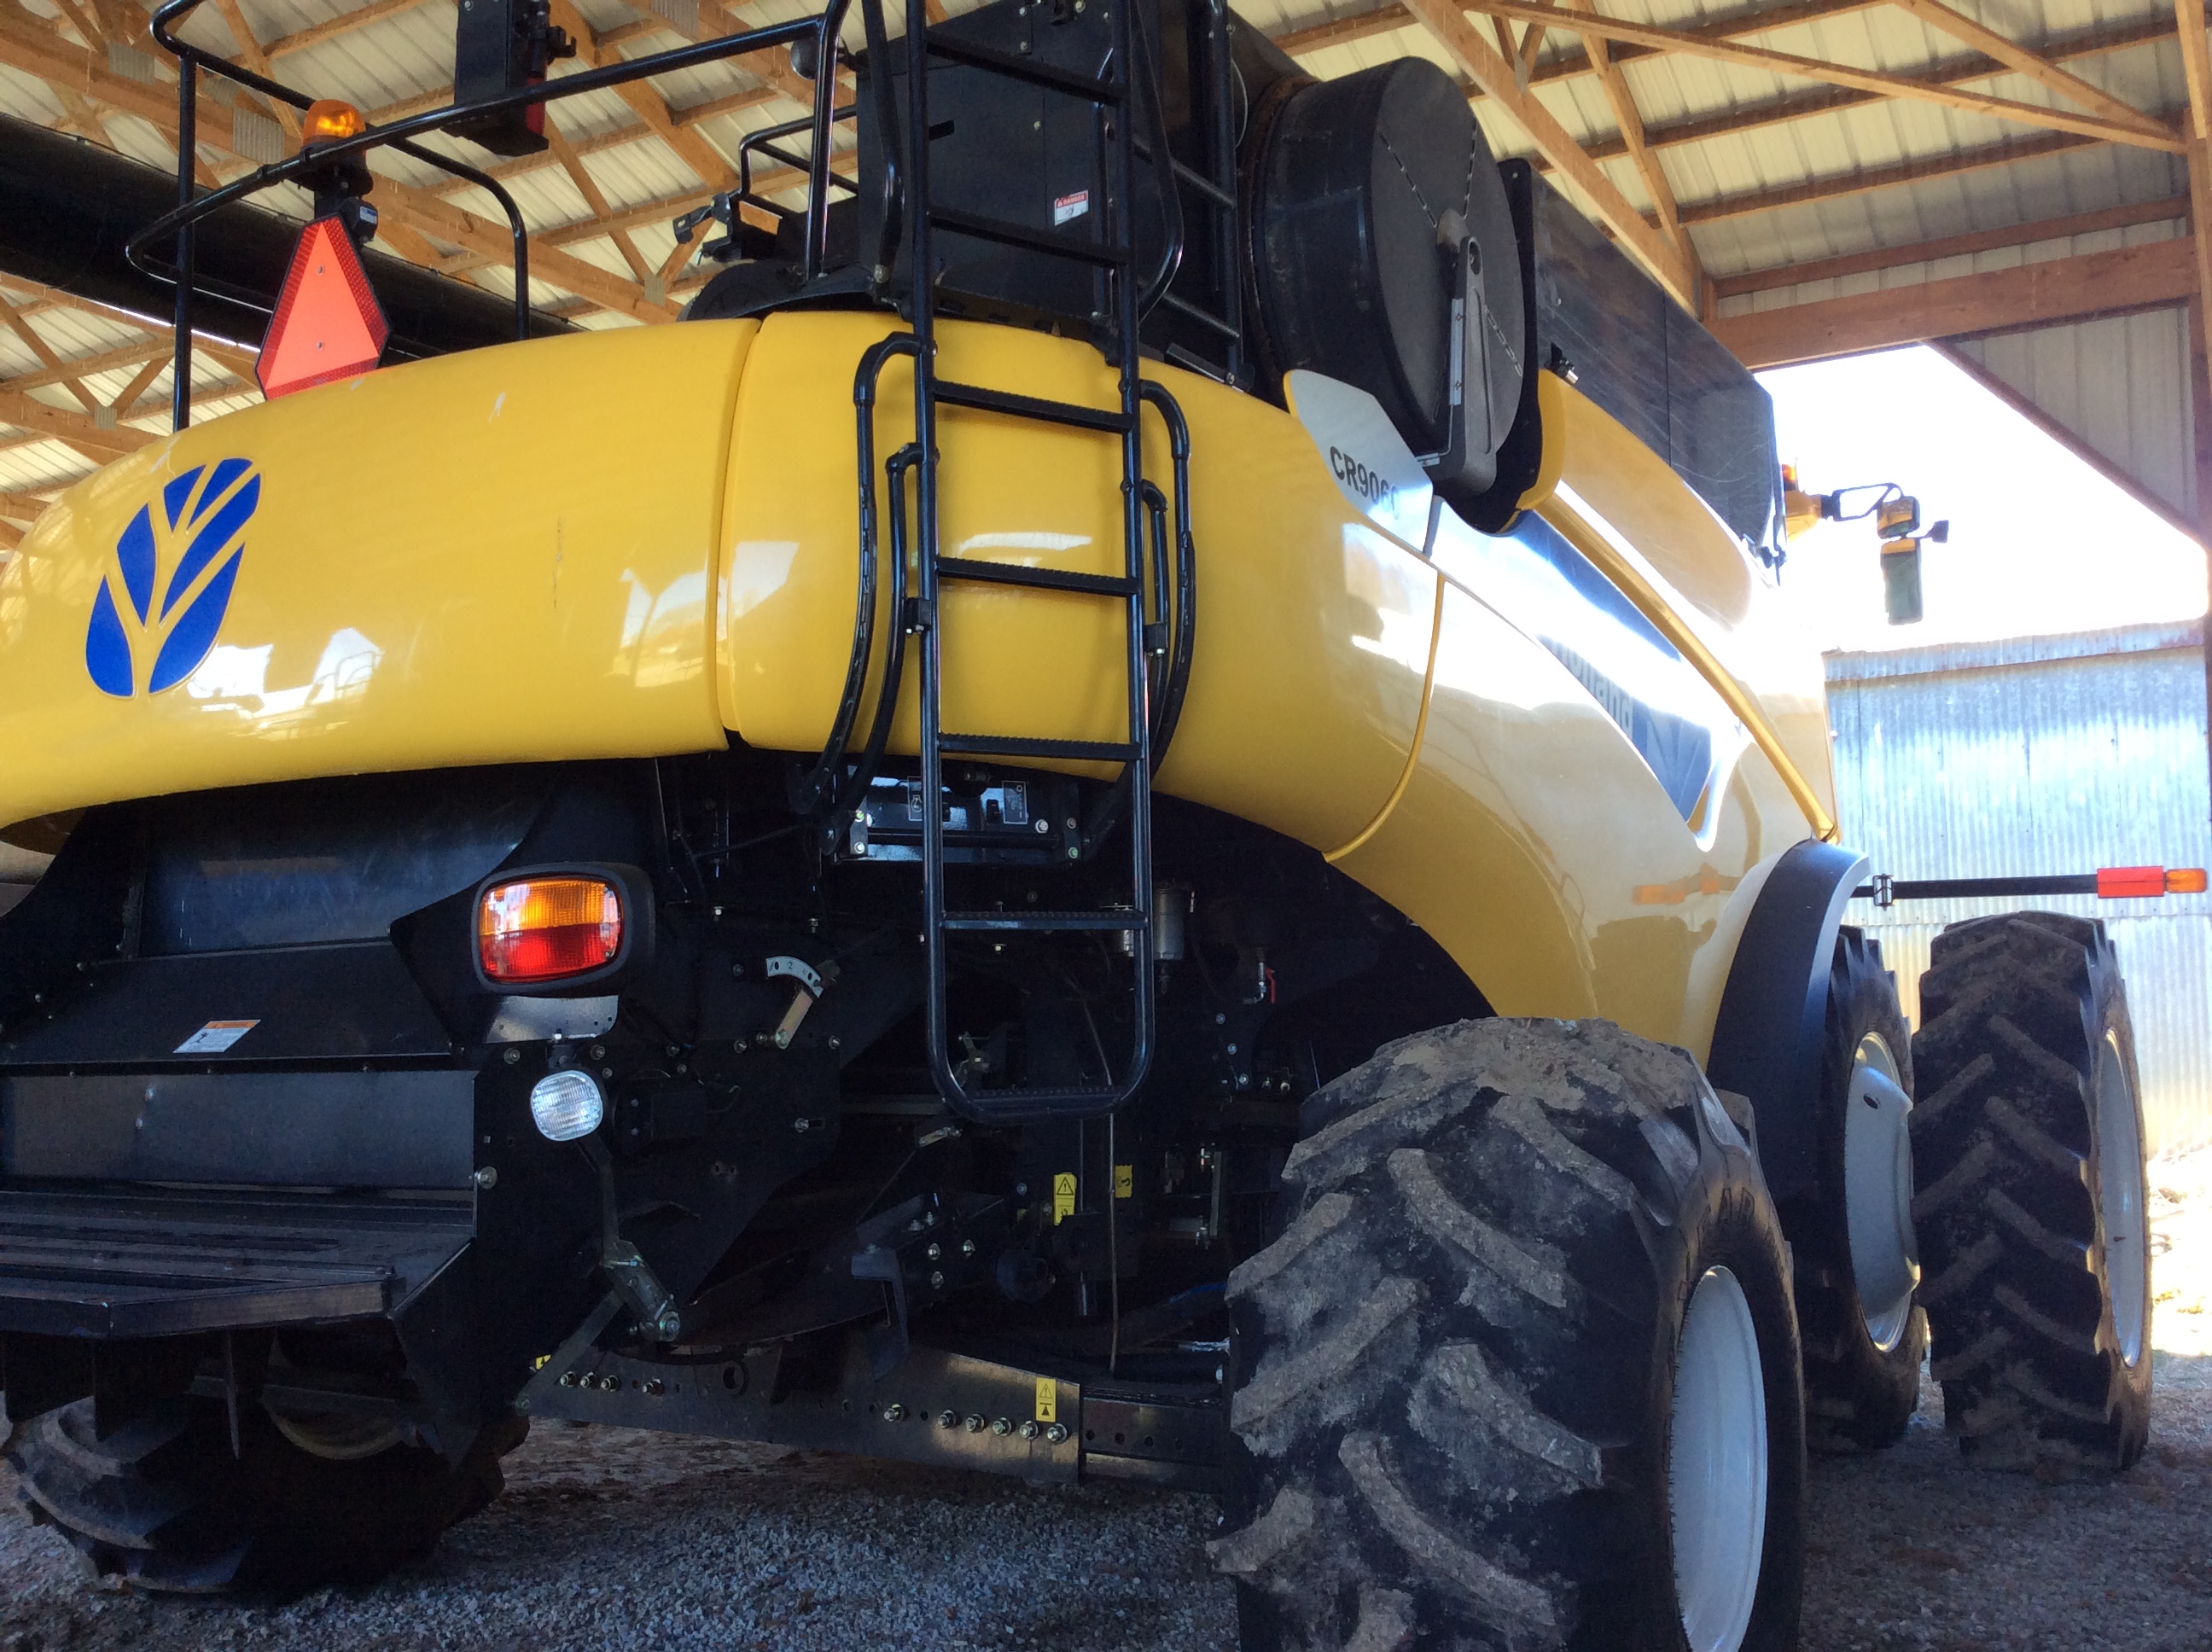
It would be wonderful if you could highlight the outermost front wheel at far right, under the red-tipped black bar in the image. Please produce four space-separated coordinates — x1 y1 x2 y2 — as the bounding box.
1911 911 2150 1473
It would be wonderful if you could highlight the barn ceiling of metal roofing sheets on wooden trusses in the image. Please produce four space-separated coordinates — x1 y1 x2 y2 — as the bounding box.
0 0 2212 541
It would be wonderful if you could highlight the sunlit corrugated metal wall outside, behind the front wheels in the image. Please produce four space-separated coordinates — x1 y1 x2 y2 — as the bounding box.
1827 624 2212 1152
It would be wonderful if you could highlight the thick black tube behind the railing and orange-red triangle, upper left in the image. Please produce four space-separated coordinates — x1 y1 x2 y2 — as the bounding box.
0 115 573 360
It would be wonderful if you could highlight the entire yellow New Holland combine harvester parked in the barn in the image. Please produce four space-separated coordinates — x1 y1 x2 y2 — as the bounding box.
0 0 2150 1652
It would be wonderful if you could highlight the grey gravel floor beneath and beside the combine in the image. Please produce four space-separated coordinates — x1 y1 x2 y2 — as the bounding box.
13 1152 2212 1652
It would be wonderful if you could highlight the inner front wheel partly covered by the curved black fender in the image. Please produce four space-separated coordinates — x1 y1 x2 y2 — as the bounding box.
1785 929 1929 1453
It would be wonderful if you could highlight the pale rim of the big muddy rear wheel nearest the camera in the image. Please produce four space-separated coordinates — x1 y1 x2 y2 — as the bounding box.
1668 1267 1767 1652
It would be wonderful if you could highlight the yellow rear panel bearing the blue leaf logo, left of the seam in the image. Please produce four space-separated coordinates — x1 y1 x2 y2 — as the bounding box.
0 321 759 823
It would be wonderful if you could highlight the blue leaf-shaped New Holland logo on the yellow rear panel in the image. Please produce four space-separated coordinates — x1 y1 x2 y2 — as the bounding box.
84 460 261 699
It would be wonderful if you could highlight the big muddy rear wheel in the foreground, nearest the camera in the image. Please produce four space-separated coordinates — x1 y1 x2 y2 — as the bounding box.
1210 1020 1805 1652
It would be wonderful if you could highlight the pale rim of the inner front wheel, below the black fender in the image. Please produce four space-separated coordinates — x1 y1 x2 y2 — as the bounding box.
1842 1032 1920 1353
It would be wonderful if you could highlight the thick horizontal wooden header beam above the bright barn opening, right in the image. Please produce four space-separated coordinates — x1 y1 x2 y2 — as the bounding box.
1710 239 2197 367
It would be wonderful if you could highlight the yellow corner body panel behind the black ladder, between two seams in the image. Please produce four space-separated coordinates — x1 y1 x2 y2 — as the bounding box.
719 314 1435 849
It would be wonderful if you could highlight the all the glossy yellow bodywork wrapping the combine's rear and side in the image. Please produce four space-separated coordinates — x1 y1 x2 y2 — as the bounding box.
0 311 1834 1053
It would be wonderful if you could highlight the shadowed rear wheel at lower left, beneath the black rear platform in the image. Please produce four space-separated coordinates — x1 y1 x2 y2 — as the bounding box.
7 1398 527 1597
